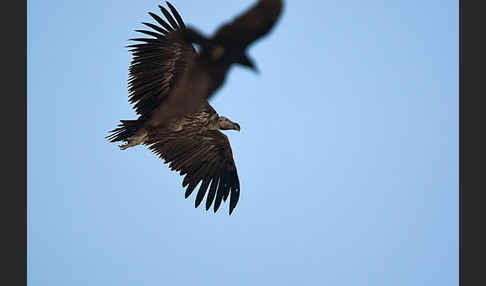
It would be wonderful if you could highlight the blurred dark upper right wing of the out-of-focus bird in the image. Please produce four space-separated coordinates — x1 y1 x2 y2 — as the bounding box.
213 0 283 47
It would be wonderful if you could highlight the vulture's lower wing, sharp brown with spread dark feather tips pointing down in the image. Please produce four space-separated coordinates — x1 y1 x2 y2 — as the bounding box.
147 110 240 215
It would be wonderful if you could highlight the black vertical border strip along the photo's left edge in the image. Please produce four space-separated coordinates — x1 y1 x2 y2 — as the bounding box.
0 1 27 285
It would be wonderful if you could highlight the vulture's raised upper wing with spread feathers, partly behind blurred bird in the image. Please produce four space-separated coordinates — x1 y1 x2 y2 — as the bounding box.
128 2 197 117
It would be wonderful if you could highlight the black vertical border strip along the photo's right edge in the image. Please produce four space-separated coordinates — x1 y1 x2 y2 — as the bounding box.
459 0 486 285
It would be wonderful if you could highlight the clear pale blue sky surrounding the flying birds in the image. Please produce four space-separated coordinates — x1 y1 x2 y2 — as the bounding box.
27 0 458 286
